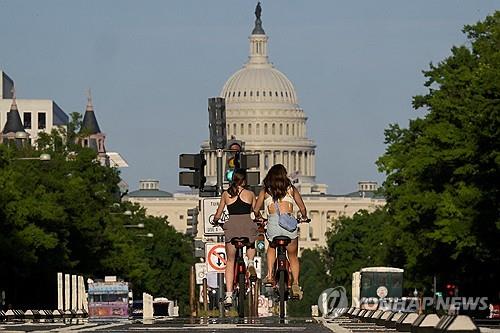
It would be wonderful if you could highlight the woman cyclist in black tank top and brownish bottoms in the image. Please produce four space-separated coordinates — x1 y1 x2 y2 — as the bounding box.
214 169 257 305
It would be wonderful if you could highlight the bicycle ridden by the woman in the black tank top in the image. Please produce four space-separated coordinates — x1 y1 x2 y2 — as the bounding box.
211 221 257 318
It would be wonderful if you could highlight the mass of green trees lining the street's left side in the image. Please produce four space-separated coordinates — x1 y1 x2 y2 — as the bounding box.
0 116 193 309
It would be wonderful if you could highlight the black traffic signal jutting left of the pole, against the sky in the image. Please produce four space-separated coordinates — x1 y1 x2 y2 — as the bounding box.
179 152 207 190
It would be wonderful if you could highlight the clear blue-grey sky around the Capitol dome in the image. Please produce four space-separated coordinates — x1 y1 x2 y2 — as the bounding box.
0 0 500 193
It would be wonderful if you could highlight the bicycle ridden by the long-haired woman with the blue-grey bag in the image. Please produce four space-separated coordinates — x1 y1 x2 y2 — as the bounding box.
259 218 311 319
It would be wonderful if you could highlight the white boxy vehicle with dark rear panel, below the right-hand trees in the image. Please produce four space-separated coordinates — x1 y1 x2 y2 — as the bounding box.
352 267 404 309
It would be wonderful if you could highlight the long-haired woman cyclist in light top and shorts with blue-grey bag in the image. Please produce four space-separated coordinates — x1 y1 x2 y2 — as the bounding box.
254 164 307 298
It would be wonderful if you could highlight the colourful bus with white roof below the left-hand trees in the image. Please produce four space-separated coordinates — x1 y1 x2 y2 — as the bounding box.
88 276 129 319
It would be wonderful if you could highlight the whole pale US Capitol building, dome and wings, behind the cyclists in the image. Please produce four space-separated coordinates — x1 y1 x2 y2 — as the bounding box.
127 6 385 250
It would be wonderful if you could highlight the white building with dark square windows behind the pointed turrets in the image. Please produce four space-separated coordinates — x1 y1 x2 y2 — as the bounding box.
0 71 68 142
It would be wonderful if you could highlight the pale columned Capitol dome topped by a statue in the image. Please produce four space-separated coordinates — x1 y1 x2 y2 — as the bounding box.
201 5 327 194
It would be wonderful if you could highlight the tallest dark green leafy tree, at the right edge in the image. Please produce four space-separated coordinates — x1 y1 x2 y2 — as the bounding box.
377 12 500 296
